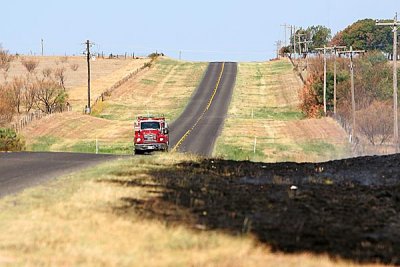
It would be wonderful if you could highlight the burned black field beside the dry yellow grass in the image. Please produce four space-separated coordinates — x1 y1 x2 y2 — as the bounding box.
107 155 400 265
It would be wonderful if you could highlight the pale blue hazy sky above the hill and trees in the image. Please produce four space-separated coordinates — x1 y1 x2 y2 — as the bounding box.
0 0 400 61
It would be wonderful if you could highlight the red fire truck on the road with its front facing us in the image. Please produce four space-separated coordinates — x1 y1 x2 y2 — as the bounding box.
134 115 169 154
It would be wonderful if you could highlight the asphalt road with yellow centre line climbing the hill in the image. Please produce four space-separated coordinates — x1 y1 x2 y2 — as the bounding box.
170 62 237 156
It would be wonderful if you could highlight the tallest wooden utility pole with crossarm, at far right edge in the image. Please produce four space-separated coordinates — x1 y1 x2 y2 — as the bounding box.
376 13 400 153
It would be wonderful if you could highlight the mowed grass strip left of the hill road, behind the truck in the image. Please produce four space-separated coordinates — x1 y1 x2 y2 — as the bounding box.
23 59 207 154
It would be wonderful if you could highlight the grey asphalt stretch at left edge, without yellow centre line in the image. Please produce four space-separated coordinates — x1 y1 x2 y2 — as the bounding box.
0 152 118 198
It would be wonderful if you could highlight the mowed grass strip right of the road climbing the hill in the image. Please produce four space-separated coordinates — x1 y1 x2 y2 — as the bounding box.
214 60 350 162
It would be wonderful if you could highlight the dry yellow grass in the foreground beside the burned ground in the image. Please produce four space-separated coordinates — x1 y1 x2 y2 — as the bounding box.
0 154 382 267
